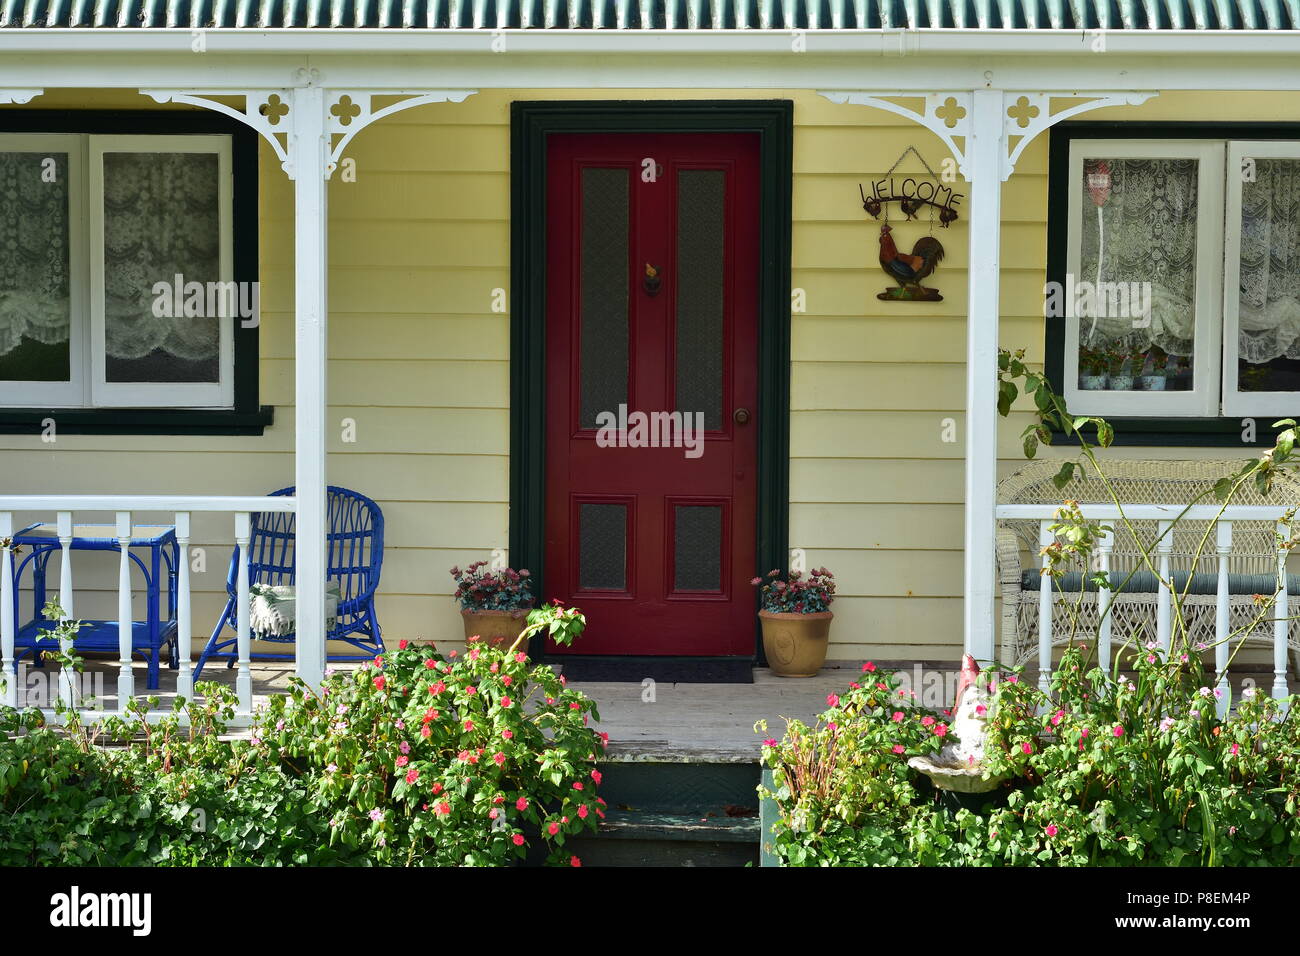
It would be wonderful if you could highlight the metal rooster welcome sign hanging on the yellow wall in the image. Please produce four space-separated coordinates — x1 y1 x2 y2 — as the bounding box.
858 147 961 302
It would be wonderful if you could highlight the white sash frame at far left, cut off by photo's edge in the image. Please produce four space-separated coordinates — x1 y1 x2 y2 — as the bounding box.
0 133 87 408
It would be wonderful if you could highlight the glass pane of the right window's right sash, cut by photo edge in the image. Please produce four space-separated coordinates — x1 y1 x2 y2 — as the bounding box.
1238 159 1300 392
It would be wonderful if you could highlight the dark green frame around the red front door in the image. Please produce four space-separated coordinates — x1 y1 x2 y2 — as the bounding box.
510 100 794 662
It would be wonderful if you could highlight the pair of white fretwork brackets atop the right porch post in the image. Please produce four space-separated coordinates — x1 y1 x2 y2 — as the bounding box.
822 90 1156 182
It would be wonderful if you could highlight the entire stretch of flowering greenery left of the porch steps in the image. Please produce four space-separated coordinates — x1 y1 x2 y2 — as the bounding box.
0 605 606 866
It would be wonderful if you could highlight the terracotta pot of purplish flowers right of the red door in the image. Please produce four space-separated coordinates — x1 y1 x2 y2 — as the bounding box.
750 567 835 678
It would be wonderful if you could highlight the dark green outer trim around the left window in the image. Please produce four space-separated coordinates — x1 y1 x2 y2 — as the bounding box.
0 109 274 434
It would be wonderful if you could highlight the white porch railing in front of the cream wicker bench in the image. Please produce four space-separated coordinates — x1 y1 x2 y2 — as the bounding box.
996 503 1291 711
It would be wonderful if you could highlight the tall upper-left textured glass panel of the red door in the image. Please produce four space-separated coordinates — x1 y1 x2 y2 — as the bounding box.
579 169 628 428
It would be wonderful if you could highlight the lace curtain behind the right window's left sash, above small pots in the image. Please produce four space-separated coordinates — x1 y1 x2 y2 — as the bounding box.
1074 159 1197 355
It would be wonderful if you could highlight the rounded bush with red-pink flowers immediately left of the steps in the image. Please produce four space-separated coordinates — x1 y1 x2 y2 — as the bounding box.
263 605 605 865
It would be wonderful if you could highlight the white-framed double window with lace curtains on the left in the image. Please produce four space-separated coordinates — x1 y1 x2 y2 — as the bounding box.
0 133 237 408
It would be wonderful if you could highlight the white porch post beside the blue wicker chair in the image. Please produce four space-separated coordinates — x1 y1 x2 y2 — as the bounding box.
287 85 329 687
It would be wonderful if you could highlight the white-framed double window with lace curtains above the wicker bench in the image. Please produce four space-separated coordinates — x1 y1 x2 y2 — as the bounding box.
1047 138 1300 418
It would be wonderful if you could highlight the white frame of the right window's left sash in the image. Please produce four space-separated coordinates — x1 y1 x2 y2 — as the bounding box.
1063 138 1225 418
